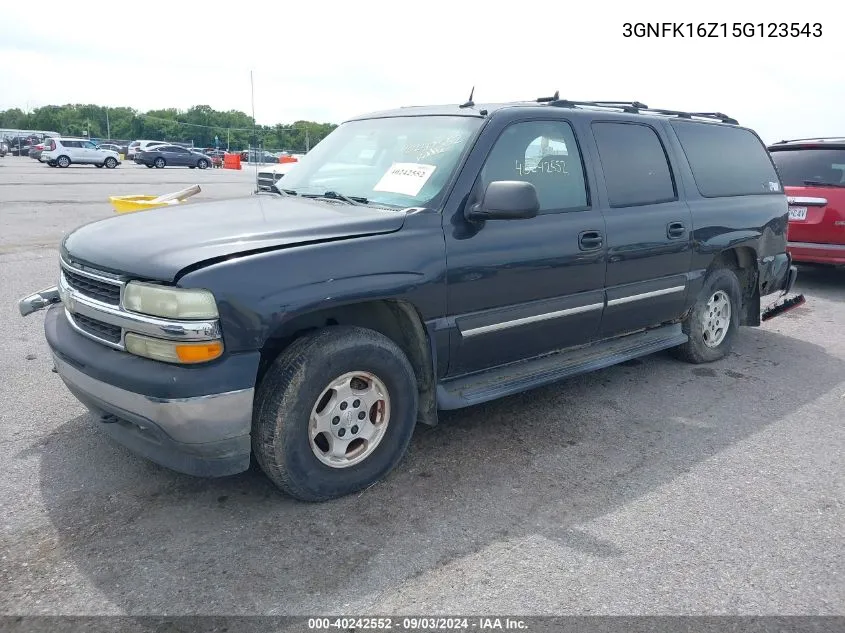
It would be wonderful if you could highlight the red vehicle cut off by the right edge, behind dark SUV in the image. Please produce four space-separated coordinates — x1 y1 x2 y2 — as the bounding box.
769 137 845 265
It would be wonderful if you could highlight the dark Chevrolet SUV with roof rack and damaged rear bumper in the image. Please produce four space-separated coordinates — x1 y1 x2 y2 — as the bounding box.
20 95 796 500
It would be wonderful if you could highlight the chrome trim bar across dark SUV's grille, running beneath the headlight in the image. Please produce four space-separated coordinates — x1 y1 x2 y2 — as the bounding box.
59 274 221 349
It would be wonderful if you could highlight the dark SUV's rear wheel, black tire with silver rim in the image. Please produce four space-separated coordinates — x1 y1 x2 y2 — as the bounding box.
671 267 742 364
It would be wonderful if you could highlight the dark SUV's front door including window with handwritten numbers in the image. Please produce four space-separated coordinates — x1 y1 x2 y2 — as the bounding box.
444 119 606 376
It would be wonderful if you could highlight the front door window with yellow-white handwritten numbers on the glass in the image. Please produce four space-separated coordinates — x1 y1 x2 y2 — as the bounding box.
474 121 589 213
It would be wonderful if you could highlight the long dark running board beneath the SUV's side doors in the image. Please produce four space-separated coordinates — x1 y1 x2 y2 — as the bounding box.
437 324 689 409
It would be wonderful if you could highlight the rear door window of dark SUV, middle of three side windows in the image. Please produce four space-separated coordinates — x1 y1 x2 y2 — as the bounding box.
592 123 677 207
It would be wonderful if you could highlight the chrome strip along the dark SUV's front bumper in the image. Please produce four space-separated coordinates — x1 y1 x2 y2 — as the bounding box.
53 354 254 443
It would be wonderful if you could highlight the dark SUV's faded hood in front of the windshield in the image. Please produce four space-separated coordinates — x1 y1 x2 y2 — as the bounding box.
61 194 405 281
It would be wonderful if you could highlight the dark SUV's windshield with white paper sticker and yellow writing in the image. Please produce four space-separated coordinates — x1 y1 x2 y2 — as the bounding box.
277 116 483 208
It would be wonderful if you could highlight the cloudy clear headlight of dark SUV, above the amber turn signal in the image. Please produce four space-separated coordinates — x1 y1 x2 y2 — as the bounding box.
123 281 218 319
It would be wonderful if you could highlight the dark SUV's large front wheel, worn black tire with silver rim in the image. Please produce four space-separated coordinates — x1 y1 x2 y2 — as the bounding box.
252 326 418 501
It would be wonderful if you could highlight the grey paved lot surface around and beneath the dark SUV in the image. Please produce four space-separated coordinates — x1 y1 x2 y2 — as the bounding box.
0 157 845 615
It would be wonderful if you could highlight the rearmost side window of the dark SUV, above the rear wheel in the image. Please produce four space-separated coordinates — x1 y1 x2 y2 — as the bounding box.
672 121 781 198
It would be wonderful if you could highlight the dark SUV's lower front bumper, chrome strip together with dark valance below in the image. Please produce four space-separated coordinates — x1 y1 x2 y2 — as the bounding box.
53 354 254 477
